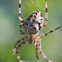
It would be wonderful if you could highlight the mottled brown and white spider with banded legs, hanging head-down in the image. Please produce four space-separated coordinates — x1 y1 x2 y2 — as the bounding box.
13 0 61 62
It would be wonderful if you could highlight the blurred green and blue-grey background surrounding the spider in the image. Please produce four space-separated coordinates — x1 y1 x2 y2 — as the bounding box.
0 0 62 62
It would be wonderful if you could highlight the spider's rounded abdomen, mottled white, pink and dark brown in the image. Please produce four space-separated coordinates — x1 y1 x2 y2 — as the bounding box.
24 11 44 34
